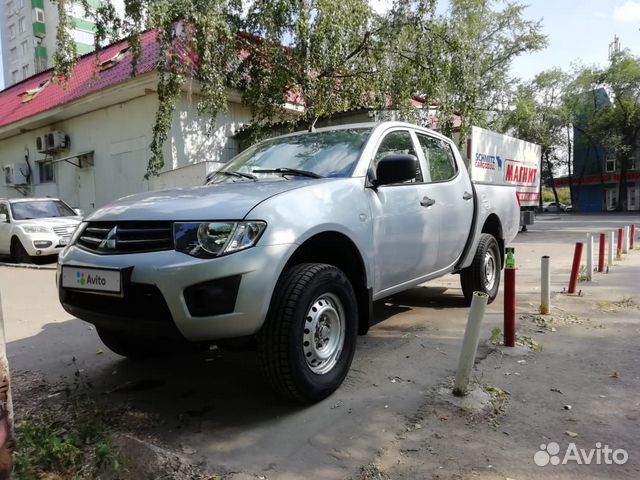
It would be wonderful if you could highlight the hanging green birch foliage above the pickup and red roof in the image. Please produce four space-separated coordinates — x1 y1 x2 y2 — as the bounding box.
55 0 546 177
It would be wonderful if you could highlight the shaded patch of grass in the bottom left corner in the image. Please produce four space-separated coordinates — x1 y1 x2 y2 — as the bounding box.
14 398 120 480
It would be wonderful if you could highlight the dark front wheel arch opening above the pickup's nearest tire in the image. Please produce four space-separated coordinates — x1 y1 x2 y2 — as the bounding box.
282 231 373 335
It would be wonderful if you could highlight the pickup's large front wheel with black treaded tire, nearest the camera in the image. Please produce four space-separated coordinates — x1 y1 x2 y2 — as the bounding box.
257 263 358 403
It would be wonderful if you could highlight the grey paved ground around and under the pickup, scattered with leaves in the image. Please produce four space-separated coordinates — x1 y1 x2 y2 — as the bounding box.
0 215 640 480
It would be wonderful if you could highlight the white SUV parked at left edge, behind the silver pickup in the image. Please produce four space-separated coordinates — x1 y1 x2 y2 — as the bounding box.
0 198 82 263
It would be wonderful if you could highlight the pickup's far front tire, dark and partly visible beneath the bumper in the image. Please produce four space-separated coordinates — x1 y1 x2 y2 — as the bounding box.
96 327 194 360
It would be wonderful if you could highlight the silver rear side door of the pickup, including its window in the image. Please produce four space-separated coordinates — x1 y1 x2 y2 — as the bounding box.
416 132 473 272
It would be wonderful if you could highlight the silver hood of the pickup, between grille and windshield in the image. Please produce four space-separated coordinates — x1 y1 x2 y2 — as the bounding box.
86 179 332 221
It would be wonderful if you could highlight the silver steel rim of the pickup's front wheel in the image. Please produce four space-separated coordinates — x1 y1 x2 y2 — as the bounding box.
302 293 345 375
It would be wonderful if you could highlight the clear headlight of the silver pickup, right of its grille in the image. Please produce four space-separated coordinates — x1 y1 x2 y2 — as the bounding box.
173 221 267 258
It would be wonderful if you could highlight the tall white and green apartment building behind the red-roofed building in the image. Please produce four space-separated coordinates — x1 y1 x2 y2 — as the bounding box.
0 0 100 87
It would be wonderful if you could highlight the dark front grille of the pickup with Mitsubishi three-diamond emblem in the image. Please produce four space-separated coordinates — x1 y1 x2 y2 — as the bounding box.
77 222 173 254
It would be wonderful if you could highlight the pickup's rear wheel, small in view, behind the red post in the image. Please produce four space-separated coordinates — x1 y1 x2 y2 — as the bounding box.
460 233 502 305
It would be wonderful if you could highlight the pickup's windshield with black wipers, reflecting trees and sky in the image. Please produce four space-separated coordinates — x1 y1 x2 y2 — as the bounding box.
208 128 371 183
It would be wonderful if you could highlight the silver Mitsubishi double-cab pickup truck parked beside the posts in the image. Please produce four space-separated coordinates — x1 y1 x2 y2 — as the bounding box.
57 122 519 402
